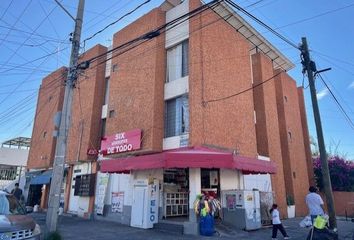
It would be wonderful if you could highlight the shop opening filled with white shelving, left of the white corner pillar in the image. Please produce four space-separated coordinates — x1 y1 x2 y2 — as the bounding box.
163 168 189 220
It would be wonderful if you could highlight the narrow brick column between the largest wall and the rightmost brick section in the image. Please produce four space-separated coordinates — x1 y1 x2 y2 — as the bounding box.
252 53 287 216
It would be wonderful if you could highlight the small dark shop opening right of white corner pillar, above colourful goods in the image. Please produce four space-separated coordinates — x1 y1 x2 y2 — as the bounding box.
200 168 220 199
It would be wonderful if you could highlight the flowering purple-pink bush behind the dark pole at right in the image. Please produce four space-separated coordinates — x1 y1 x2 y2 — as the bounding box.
313 156 354 192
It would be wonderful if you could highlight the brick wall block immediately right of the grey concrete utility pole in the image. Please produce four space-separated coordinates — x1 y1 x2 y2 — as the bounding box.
66 45 107 163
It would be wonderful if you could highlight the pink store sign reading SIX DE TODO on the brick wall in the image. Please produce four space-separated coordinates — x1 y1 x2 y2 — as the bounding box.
101 129 141 155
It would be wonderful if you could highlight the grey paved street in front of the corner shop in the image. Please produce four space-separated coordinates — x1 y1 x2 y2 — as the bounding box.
33 214 354 240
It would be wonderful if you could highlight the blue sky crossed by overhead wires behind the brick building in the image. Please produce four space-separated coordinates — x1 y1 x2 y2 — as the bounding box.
0 0 354 159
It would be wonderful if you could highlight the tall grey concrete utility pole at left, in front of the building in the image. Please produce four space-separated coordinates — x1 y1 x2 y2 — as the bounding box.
46 0 85 234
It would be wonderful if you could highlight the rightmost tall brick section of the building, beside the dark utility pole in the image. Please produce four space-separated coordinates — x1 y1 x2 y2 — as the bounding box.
274 71 309 216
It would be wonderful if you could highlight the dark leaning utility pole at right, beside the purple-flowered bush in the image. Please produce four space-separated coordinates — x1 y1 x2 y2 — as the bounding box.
301 37 337 229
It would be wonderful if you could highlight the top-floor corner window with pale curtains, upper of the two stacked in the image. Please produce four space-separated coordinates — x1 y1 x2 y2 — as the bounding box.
166 40 189 82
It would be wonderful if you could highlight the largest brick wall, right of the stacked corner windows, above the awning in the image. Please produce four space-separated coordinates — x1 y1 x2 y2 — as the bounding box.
189 0 257 157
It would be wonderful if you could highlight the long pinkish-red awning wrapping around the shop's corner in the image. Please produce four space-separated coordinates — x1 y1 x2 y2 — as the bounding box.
101 147 276 174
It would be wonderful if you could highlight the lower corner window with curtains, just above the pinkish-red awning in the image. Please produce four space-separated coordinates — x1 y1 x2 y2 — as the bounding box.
165 95 189 137
